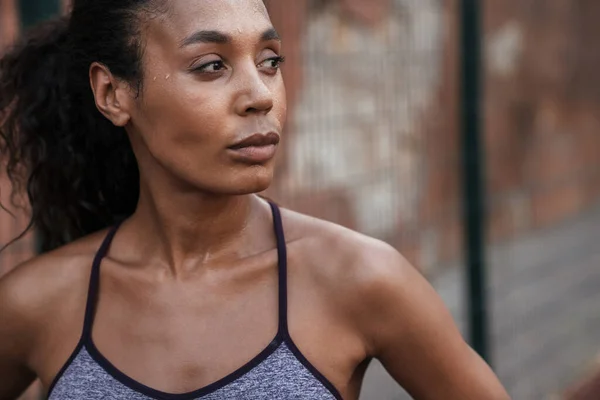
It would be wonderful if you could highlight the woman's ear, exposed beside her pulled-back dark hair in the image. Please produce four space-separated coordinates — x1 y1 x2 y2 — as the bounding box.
90 62 133 127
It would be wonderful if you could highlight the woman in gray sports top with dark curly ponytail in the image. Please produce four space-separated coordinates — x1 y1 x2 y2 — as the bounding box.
0 0 508 400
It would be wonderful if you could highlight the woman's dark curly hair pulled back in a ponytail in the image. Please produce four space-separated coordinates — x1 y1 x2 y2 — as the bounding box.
0 0 166 251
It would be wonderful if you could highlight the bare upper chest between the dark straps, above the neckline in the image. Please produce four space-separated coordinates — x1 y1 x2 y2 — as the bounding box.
91 266 278 392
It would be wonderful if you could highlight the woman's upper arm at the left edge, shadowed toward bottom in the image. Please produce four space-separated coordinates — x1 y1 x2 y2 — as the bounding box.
0 264 40 400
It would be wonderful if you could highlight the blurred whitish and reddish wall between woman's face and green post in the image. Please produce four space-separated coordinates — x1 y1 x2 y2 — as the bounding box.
271 0 459 274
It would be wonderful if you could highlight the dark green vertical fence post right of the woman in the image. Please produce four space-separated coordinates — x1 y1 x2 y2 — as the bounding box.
460 0 490 363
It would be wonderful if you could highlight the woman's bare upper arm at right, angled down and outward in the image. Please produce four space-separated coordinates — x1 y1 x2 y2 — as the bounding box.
358 245 509 400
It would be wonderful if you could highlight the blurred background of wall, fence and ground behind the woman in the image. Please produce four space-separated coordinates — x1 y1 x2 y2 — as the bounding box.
0 0 600 400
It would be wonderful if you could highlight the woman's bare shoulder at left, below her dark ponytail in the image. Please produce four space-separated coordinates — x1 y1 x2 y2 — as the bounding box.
0 233 102 360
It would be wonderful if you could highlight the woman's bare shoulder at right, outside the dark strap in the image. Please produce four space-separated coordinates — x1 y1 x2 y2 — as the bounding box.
284 211 450 357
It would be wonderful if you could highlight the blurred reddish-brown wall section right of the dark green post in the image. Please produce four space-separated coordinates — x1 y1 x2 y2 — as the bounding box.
485 0 600 239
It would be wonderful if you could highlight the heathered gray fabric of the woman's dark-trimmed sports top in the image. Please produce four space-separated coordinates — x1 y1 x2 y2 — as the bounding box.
49 342 336 400
